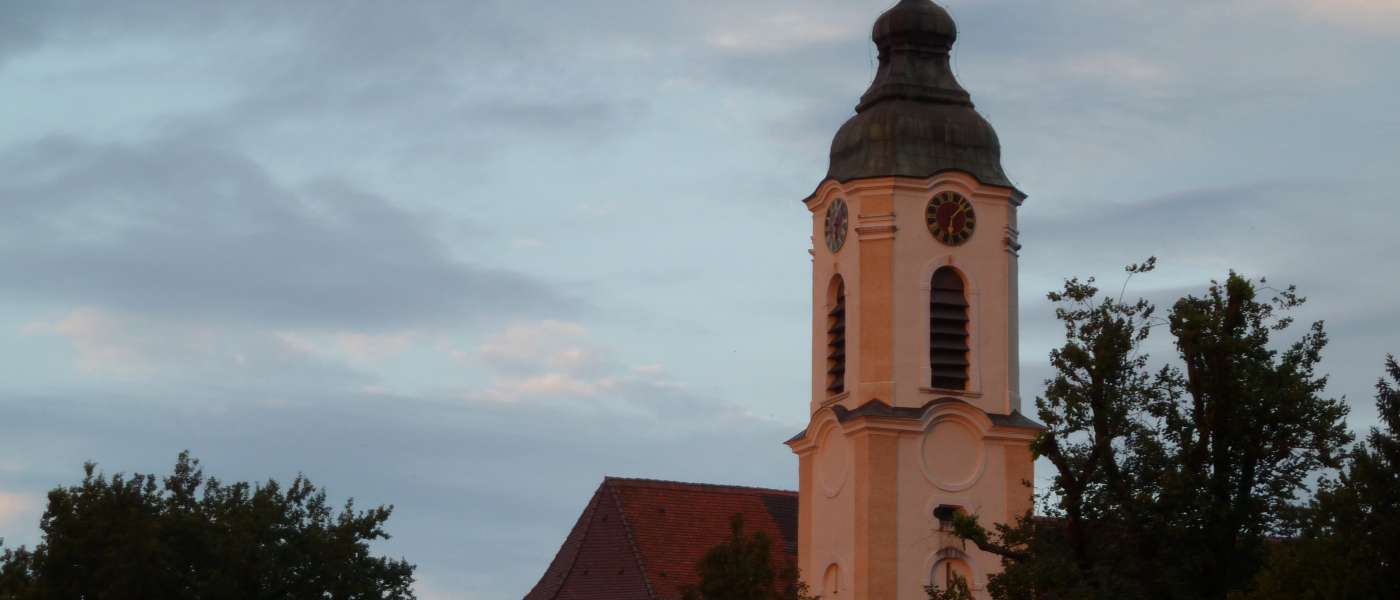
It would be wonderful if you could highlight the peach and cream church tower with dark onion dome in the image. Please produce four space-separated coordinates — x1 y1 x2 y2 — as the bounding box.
788 0 1040 600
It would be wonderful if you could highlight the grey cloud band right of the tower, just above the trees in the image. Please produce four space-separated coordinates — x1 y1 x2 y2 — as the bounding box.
1022 178 1400 274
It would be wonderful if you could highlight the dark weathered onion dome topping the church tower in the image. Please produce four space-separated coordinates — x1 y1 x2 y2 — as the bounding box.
826 0 1014 187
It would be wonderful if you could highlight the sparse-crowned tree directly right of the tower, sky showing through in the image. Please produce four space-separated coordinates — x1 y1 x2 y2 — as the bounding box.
955 260 1180 599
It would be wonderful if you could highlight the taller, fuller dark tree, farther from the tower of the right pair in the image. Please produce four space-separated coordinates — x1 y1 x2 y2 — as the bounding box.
1158 273 1351 597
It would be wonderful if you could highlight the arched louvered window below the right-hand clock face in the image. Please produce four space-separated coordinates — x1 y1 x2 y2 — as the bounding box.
928 267 970 390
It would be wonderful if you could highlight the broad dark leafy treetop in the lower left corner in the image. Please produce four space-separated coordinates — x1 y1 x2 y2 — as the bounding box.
0 452 414 600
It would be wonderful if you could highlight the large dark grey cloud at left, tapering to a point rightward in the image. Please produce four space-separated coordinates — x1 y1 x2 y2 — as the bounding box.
0 133 577 330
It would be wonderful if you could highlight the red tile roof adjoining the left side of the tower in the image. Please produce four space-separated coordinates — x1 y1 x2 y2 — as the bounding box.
525 477 797 600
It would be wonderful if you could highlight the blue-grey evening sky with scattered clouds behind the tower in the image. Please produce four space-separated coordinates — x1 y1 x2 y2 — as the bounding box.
0 0 1400 600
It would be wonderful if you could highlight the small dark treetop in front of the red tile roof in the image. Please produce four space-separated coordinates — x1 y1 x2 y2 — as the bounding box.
685 513 818 600
